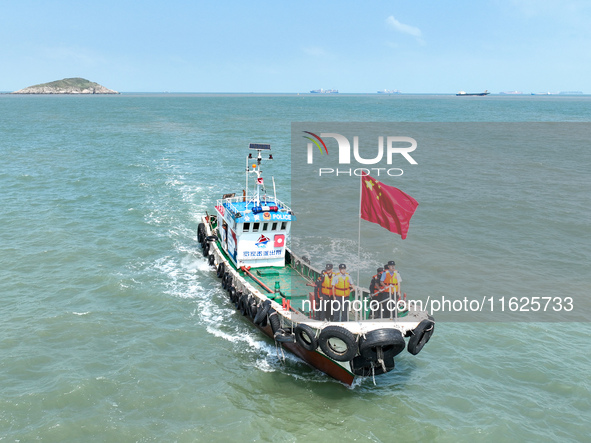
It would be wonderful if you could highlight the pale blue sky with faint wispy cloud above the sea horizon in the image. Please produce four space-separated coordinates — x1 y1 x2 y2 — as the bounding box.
0 0 591 94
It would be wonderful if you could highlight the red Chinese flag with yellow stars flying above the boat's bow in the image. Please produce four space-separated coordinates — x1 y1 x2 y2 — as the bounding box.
361 175 419 240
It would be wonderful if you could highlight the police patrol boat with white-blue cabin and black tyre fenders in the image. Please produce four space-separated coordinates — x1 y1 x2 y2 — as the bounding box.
197 143 435 385
